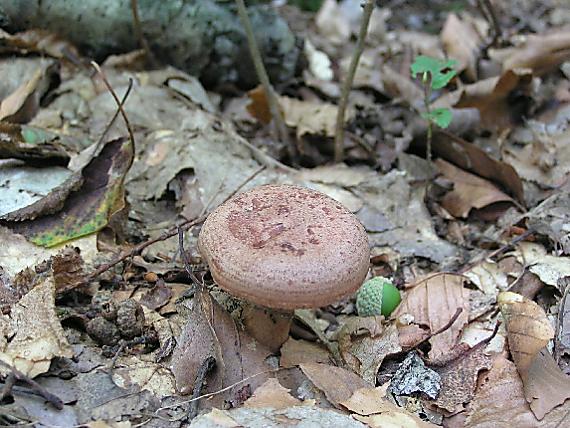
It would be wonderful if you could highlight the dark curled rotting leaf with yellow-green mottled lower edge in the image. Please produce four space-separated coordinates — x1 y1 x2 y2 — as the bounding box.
7 139 133 247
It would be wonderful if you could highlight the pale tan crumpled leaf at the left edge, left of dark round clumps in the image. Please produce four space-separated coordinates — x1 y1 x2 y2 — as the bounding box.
0 274 73 378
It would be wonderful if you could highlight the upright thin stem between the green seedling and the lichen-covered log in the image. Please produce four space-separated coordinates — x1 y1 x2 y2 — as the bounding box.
334 0 374 162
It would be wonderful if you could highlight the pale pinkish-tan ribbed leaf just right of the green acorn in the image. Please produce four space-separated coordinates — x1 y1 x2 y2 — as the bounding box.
394 273 469 360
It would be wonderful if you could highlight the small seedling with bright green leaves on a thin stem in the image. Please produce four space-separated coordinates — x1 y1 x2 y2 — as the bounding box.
410 55 457 161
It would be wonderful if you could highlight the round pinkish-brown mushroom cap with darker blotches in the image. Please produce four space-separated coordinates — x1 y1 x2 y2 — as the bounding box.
198 185 370 309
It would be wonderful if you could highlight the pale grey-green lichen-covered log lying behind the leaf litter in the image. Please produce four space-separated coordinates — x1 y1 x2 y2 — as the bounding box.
0 0 299 86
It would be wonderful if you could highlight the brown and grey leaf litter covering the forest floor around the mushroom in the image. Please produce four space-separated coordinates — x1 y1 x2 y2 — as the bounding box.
0 0 570 427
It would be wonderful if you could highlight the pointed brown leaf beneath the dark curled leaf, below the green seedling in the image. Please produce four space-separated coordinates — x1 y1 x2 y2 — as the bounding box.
436 159 513 218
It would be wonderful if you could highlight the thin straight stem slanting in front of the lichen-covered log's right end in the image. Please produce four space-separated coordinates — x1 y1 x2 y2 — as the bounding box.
232 0 297 164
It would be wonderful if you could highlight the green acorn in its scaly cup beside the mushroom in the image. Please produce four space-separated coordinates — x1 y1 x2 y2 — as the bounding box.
356 276 402 317
